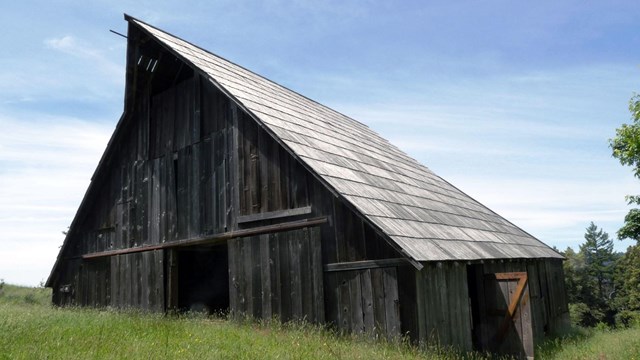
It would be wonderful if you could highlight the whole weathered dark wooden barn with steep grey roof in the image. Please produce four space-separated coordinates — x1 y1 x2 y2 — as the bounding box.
47 16 567 356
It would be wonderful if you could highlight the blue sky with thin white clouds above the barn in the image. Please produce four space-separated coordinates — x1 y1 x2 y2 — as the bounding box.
0 0 640 285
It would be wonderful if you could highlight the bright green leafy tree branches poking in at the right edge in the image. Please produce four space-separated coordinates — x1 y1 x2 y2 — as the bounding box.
609 94 640 242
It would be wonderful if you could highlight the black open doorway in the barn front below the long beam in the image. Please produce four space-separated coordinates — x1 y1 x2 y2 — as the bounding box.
178 245 229 314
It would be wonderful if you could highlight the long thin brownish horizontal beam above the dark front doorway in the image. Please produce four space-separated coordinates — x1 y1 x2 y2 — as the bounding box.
82 216 327 259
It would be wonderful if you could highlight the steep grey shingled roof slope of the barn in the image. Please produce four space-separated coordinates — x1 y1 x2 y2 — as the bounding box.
126 16 561 261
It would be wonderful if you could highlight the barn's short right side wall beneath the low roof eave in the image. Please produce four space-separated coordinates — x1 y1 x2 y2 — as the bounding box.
407 259 568 354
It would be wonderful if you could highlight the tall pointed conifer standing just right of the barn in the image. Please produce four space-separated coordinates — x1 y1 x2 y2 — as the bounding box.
580 222 615 304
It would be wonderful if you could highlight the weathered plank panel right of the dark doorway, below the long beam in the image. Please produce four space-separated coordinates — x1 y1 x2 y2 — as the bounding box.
228 227 325 323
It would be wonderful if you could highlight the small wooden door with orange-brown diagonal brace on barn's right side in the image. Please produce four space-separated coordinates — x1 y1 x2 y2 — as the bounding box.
481 272 533 359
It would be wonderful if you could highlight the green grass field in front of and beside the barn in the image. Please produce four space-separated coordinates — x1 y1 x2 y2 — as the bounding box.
0 285 640 360
